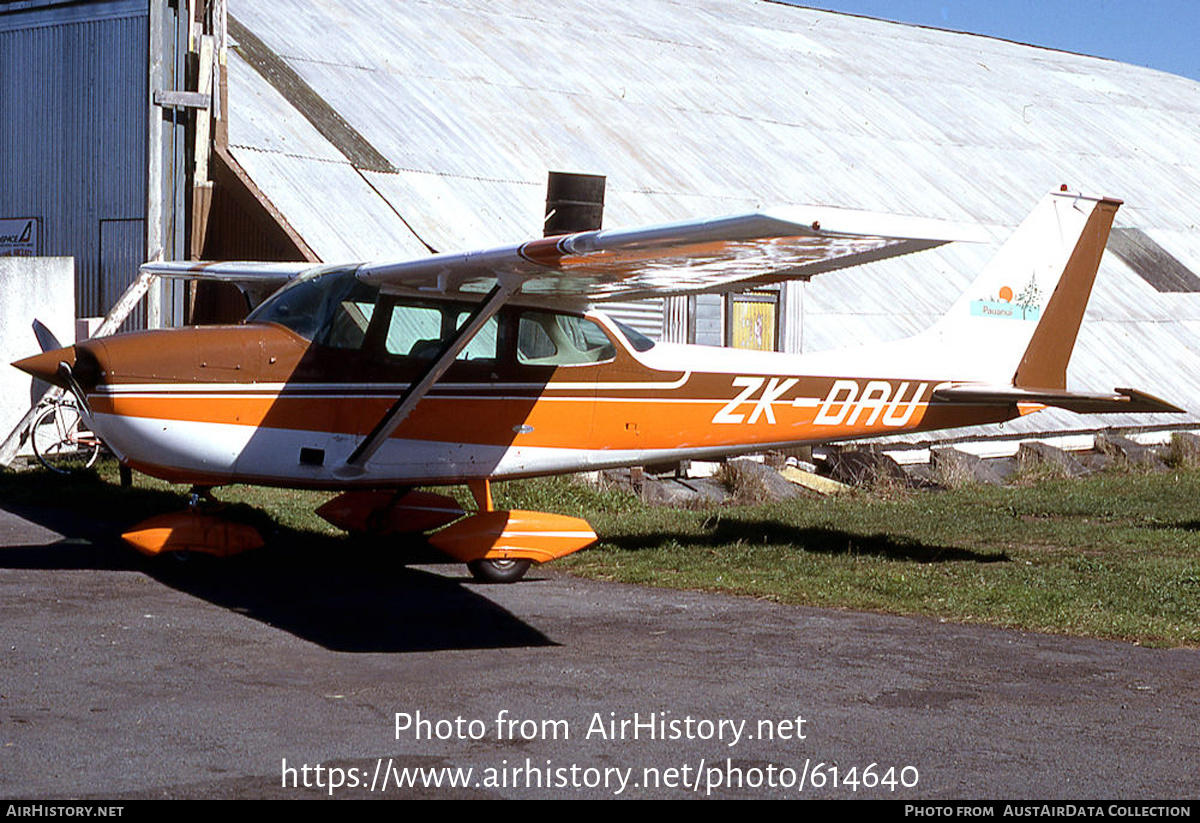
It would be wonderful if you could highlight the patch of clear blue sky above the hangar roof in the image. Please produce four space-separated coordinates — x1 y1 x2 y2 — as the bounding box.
793 0 1200 80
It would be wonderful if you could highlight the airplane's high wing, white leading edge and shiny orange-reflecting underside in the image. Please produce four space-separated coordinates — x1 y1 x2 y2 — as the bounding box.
143 206 988 304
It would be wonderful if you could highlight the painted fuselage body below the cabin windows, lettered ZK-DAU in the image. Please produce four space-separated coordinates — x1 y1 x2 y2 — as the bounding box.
70 328 1016 488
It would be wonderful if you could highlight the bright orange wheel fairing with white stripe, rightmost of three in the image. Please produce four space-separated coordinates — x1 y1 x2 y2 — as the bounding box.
430 510 596 563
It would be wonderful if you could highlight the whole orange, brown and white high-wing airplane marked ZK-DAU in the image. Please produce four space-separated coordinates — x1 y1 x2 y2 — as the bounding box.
14 192 1181 582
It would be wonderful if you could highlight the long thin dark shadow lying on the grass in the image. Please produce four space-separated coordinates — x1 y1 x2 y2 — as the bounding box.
606 517 1010 563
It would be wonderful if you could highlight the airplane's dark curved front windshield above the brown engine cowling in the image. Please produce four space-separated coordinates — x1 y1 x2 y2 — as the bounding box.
246 268 379 348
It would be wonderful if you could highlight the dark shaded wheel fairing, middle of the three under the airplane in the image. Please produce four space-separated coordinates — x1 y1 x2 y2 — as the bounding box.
317 491 467 535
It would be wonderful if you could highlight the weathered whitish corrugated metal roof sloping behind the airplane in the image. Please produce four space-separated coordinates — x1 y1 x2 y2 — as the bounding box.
220 0 1200 441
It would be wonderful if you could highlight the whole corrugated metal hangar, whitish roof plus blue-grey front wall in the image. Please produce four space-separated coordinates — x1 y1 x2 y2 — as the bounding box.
0 0 1200 451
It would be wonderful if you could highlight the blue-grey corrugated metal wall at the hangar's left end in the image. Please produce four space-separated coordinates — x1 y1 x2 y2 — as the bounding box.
0 1 148 316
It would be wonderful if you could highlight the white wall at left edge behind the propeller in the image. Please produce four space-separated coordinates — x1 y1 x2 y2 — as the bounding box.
0 257 76 451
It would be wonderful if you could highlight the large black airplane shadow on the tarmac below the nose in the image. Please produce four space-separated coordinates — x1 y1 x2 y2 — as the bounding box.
0 481 554 653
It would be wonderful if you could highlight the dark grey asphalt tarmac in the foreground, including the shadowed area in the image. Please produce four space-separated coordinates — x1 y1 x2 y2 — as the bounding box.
0 504 1200 800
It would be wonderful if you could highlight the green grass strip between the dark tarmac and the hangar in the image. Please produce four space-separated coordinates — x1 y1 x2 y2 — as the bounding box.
0 463 1200 647
